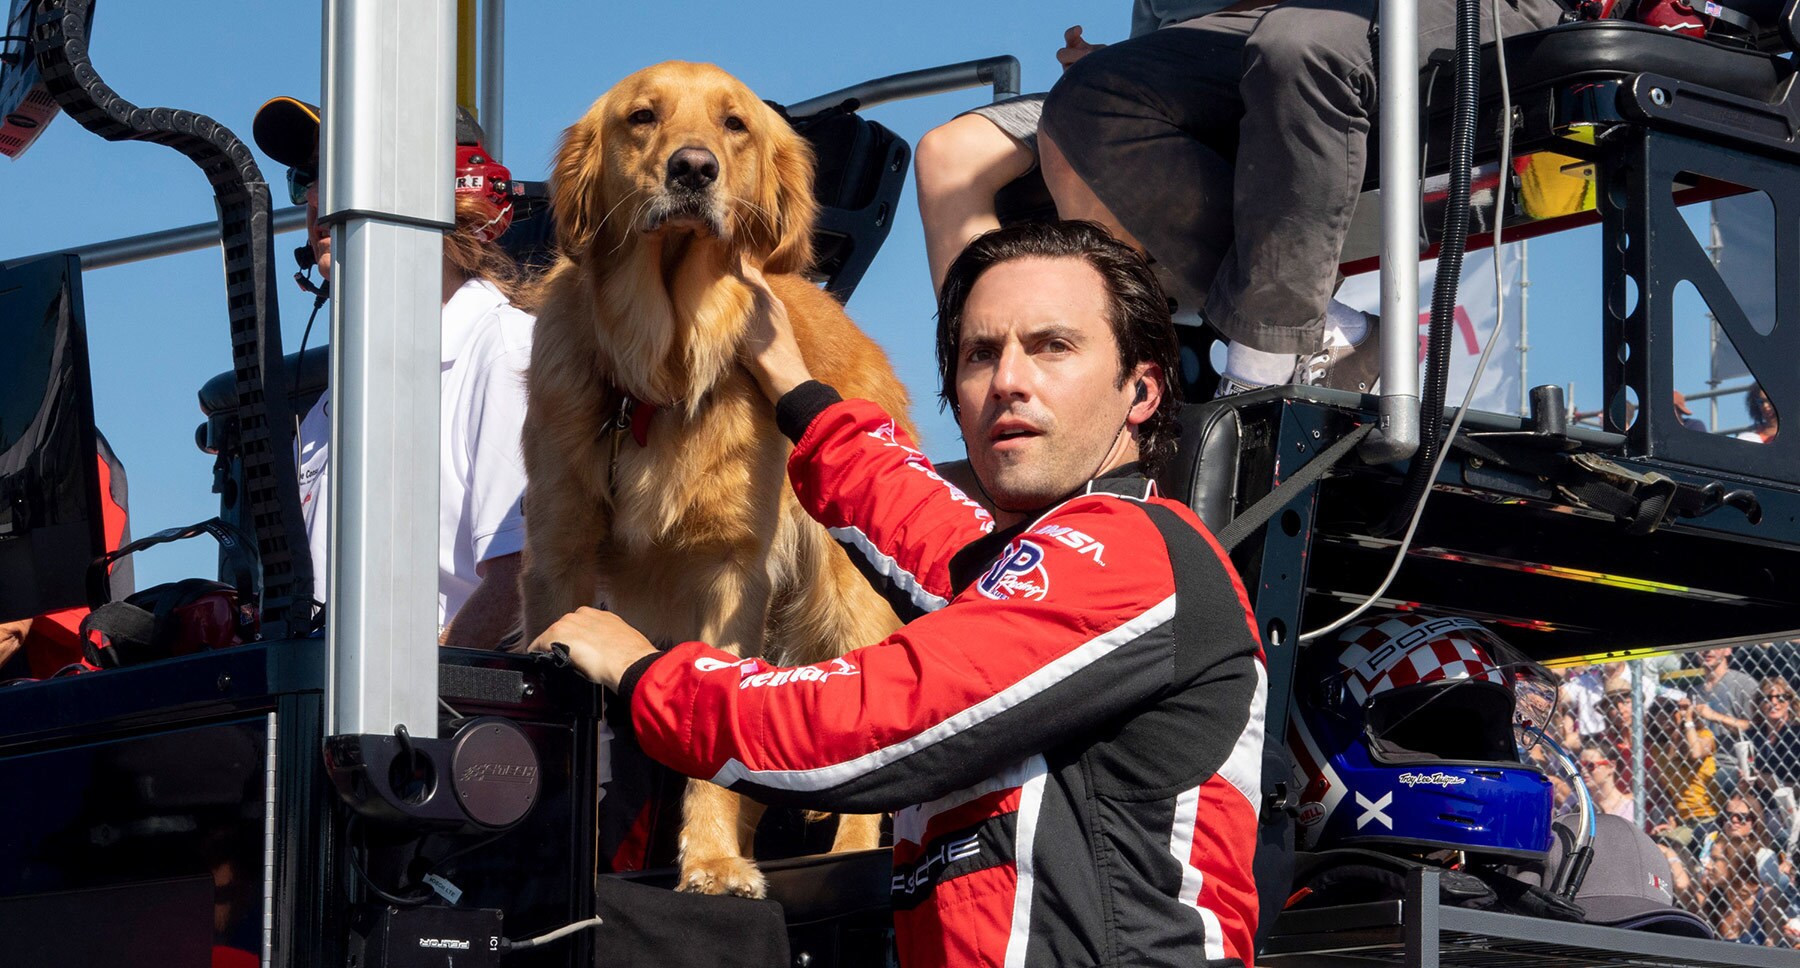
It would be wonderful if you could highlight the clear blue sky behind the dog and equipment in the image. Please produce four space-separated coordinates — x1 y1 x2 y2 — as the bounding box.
0 0 1741 585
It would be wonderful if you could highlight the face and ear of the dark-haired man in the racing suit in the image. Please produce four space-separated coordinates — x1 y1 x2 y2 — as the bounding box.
956 257 1161 511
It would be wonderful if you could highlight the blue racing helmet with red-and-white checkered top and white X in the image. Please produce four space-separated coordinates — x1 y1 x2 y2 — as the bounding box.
1289 612 1557 860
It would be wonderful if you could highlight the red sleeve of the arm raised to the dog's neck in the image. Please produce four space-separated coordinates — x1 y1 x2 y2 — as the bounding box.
788 399 994 619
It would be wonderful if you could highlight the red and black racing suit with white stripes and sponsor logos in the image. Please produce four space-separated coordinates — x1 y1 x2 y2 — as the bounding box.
619 383 1265 968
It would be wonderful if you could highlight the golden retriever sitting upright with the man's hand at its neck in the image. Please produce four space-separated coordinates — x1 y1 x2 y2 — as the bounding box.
520 61 911 896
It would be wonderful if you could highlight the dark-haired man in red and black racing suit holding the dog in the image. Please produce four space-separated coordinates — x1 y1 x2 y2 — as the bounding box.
533 223 1265 966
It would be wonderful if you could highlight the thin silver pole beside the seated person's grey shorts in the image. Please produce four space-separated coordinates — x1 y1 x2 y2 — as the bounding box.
1359 0 1418 464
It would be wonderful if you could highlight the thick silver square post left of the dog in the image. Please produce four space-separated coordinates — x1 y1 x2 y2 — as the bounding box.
320 0 455 738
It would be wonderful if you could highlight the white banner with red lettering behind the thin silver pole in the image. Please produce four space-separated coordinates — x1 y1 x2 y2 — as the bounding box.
1337 245 1521 414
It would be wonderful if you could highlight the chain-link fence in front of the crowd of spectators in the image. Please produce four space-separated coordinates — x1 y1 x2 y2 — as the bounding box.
1534 641 1800 948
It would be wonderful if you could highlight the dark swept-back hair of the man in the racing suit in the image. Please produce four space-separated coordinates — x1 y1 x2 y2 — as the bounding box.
938 221 1181 477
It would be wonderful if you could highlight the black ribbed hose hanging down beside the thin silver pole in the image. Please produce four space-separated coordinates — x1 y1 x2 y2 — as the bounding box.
1375 0 1483 536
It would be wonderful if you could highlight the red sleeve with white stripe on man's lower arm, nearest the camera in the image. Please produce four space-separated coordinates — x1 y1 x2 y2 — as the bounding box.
621 492 1188 810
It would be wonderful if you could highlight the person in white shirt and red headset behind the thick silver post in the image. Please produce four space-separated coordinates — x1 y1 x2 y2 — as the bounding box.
254 97 535 648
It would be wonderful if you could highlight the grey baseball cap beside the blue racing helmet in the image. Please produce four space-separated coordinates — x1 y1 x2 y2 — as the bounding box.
1544 813 1712 939
